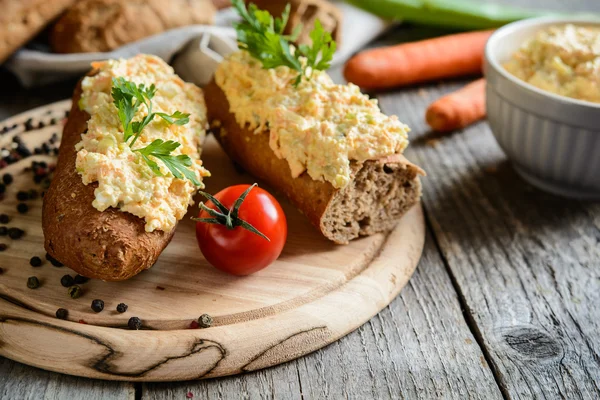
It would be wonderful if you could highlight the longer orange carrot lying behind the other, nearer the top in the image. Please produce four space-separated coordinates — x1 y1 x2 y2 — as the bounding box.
344 30 493 89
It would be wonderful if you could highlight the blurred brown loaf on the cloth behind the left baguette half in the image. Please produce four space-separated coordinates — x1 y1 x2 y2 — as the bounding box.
47 0 216 53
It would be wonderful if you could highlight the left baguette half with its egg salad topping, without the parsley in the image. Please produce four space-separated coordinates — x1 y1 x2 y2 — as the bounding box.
42 55 209 281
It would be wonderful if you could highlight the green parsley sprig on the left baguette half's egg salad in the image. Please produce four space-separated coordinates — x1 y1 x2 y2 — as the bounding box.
111 77 202 186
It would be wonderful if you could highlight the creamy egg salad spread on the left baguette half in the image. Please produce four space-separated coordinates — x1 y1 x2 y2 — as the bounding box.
76 54 210 232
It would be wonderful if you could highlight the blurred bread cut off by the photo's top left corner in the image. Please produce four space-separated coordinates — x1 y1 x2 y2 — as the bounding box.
0 0 75 63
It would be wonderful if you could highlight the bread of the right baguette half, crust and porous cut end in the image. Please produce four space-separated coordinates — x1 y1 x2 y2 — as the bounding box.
204 80 425 244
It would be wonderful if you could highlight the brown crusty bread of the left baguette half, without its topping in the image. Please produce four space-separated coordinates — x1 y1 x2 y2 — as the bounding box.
42 76 175 281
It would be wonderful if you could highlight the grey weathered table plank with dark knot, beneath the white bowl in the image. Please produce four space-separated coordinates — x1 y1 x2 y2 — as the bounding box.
379 57 600 399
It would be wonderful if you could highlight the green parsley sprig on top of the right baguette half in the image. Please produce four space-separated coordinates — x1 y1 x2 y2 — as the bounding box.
232 0 336 86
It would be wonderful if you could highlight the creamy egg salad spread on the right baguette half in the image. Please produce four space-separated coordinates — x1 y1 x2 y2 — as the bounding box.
215 51 409 188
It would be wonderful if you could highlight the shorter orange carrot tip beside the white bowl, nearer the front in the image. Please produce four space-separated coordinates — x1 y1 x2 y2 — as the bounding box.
425 78 485 132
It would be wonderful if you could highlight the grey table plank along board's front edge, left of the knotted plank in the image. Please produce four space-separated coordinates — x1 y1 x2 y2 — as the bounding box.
142 230 502 400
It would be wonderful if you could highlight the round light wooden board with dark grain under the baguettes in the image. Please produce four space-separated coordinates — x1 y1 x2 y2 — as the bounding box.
0 100 425 381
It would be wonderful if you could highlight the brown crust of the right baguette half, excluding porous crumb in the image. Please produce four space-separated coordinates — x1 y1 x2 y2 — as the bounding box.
204 79 424 244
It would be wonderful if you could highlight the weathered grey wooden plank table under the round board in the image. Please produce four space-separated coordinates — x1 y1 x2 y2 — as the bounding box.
0 0 600 400
